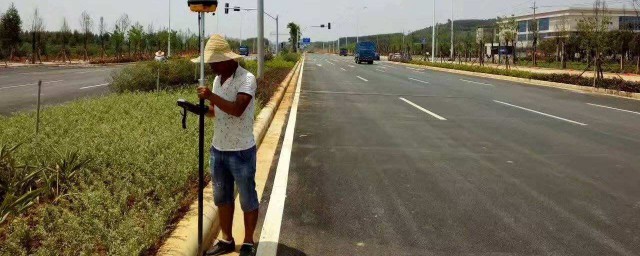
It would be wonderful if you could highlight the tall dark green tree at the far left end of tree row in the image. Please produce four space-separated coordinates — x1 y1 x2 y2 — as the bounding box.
0 3 22 60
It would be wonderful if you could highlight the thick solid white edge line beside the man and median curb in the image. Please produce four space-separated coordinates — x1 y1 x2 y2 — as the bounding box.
256 59 304 256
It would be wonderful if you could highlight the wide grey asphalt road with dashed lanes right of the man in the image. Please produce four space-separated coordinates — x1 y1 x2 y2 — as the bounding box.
263 54 640 255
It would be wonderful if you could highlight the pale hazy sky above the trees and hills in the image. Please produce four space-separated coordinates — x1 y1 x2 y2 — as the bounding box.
0 0 632 41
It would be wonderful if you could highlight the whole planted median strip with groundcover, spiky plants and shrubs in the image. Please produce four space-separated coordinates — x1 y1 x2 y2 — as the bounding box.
0 52 299 255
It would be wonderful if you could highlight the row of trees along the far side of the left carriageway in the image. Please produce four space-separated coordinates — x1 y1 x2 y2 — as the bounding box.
0 4 205 63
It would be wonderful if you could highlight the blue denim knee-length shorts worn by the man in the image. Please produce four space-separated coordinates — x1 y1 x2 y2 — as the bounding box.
209 146 259 212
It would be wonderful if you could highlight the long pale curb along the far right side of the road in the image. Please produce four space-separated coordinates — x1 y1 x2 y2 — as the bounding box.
392 62 640 100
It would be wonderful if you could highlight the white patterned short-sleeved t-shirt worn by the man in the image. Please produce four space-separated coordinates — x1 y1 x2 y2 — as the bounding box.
211 66 258 151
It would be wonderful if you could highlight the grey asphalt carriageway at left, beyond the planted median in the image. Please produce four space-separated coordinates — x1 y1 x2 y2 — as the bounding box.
0 65 122 115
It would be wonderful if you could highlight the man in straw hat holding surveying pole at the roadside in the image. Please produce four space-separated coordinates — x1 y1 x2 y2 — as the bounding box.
192 35 258 256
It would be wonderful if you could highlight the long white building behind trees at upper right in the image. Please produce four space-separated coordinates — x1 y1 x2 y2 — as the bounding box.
515 8 640 48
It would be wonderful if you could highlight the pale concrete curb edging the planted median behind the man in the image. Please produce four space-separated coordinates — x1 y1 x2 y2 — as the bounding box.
158 57 304 256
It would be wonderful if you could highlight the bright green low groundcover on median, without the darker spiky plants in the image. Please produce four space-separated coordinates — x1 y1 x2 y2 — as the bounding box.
0 89 261 255
